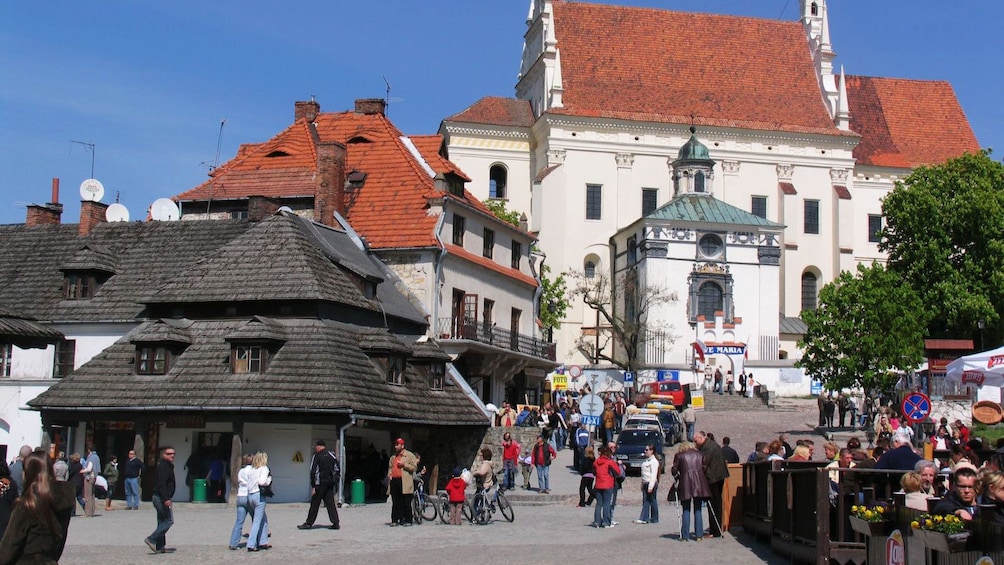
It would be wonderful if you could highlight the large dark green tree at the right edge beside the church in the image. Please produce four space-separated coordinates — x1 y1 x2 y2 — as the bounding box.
880 152 1004 347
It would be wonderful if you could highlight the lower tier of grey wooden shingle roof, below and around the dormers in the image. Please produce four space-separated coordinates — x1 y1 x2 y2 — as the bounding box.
29 318 486 426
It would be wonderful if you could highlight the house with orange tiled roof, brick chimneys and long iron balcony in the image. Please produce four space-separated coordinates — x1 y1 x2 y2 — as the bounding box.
174 99 557 411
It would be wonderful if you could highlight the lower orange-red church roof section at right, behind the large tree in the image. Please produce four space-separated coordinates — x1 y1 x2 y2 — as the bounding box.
846 76 980 169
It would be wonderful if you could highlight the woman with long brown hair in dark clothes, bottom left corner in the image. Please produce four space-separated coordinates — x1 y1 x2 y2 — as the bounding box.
0 452 74 565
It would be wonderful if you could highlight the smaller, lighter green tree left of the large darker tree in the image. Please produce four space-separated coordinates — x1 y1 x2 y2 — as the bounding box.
795 263 928 390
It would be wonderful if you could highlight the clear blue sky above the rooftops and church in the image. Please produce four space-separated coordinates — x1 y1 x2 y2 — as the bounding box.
0 0 1004 224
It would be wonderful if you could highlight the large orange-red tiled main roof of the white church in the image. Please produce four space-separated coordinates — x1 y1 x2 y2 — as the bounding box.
549 0 851 135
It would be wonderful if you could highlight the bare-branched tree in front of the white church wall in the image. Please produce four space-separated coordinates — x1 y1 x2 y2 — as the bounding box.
565 268 678 371
